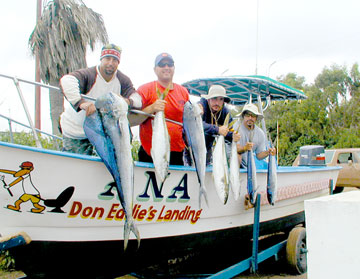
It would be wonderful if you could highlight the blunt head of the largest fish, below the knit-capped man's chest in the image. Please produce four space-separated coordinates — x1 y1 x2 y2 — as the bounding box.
95 92 128 119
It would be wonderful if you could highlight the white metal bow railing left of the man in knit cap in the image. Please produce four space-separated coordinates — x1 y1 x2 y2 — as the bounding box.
0 73 62 150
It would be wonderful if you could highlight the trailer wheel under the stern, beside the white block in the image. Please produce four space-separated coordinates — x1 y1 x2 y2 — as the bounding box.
286 227 307 274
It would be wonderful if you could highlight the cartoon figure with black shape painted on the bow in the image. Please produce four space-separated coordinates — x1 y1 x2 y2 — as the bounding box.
0 161 74 213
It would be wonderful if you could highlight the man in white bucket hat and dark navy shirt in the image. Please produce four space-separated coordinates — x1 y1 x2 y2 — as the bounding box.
199 85 240 164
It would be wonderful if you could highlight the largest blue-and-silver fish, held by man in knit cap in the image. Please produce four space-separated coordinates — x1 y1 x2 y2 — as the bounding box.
84 93 140 249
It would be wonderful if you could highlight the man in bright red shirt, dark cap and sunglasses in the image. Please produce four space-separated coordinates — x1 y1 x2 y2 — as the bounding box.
137 53 189 165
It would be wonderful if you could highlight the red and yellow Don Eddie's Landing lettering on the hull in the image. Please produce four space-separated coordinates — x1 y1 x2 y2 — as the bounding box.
68 201 202 224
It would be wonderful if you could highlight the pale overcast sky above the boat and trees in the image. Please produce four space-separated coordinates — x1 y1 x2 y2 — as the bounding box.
0 0 360 132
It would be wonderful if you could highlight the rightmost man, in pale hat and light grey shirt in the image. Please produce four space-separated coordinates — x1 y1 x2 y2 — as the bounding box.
237 104 276 167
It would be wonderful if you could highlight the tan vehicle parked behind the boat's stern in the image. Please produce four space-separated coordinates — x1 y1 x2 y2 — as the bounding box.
293 148 360 193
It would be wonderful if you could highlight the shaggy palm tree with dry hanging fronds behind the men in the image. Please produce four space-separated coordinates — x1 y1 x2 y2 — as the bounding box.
29 0 108 134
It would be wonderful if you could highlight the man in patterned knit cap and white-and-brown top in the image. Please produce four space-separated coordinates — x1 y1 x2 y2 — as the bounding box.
60 44 142 155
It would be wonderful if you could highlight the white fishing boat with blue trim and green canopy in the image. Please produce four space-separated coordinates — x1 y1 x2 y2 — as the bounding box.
0 76 339 278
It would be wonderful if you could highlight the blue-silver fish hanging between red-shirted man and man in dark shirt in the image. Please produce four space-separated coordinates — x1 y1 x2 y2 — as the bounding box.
183 102 208 207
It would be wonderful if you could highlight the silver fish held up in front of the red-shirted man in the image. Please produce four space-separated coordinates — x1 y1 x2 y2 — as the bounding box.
150 87 170 184
